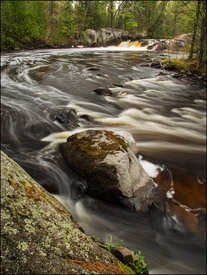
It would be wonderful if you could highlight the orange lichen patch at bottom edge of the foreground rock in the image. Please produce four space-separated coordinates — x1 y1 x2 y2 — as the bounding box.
66 259 126 274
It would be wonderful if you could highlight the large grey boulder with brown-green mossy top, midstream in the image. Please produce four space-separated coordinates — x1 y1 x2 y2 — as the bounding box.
60 130 156 211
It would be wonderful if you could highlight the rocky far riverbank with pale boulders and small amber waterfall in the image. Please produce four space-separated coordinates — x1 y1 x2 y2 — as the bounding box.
1 28 192 51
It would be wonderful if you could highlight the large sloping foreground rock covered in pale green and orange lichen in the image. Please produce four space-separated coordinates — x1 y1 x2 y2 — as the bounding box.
1 152 126 275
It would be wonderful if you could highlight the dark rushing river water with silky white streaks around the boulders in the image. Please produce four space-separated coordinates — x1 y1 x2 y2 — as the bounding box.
1 48 206 274
